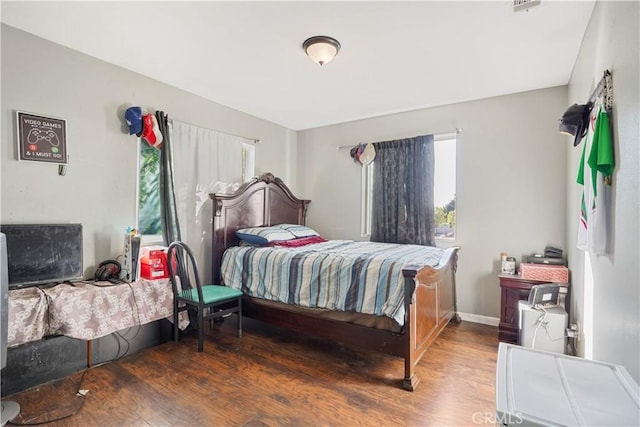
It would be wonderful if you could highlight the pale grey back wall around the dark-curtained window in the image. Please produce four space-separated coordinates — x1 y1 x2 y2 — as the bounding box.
298 87 567 317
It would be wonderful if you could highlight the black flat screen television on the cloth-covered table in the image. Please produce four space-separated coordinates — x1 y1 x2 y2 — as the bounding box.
0 224 83 289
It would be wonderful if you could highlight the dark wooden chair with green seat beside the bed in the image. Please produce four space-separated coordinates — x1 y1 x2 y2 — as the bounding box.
167 241 242 352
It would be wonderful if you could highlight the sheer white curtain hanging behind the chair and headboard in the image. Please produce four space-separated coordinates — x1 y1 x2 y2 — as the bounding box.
171 120 255 283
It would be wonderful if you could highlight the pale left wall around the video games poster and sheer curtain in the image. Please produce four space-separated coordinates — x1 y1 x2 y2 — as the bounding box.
0 24 296 276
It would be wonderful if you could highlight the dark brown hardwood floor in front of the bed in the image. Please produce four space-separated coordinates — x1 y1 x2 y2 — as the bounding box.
5 319 498 426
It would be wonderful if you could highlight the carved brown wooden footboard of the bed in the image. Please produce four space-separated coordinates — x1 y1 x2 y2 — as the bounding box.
402 247 460 391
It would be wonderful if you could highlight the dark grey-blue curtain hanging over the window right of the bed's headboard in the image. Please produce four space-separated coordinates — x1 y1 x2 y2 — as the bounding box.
371 135 435 246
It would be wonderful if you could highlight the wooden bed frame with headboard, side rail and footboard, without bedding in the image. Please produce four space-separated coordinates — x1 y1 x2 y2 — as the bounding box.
210 173 460 391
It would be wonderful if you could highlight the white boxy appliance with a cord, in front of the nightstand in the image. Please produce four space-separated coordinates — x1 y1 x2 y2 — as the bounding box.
518 301 569 354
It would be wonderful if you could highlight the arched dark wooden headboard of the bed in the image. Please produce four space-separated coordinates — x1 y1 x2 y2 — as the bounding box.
209 172 311 283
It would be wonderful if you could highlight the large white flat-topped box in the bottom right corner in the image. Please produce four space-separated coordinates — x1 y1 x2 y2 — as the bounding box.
496 343 640 426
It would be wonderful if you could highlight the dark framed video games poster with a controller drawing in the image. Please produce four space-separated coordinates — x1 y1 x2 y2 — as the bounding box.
16 111 67 164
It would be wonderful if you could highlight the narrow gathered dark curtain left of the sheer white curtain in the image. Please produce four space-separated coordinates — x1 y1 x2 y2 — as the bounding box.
156 111 181 246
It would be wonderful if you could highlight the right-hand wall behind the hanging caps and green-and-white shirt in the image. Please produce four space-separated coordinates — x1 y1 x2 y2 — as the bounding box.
566 1 640 381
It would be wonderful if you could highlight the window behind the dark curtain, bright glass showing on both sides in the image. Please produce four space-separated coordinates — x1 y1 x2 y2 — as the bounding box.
361 133 456 240
